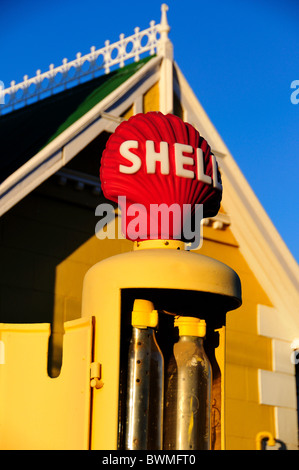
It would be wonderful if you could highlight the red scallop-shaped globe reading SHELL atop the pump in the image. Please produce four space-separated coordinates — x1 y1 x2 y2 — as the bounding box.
100 112 222 239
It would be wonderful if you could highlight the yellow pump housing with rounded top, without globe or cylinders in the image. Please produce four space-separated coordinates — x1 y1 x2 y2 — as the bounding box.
82 240 241 449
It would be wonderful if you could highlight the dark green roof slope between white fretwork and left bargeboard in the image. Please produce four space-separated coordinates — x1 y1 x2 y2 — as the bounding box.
0 57 151 183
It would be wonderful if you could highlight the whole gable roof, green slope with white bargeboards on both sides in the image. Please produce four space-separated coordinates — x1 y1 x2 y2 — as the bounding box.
0 9 299 337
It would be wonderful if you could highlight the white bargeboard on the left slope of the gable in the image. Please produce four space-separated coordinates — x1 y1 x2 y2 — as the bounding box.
0 57 162 216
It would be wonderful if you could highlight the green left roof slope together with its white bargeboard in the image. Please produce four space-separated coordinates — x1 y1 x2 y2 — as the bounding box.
0 56 161 215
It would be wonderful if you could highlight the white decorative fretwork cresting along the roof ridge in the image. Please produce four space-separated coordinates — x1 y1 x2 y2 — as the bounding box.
0 4 169 114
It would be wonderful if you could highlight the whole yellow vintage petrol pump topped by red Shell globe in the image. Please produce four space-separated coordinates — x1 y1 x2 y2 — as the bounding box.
82 113 241 450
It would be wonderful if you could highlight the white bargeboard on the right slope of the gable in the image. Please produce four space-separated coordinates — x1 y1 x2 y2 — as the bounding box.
175 60 299 326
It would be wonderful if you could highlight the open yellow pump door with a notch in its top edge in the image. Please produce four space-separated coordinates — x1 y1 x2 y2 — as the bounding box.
0 318 93 450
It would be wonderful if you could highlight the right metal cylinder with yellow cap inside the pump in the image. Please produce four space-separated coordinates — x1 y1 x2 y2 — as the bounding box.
163 317 212 450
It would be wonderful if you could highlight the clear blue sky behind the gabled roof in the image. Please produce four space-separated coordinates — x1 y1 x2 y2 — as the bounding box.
0 0 299 261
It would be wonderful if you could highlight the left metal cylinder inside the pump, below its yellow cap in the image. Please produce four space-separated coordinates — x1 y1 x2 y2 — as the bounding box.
125 302 164 450
